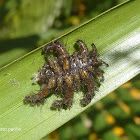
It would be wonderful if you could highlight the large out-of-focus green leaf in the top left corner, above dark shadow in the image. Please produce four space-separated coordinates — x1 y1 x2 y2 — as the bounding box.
0 0 63 38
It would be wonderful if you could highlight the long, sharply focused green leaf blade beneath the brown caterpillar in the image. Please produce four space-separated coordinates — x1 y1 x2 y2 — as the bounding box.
0 0 140 140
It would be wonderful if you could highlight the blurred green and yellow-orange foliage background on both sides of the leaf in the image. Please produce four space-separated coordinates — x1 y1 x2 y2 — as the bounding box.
0 0 140 140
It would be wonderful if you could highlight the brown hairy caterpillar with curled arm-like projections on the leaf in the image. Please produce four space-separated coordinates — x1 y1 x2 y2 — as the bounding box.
24 39 108 109
